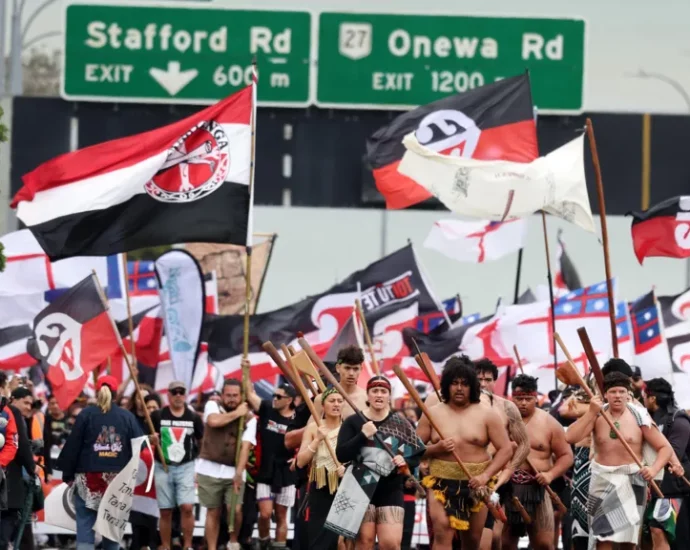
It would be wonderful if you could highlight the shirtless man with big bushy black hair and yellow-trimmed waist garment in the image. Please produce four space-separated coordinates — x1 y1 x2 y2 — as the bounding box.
417 355 513 550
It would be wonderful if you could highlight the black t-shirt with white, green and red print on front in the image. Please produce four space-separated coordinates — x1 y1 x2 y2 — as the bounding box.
151 407 204 466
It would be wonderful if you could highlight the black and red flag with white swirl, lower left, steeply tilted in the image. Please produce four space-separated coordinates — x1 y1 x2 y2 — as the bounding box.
30 275 119 409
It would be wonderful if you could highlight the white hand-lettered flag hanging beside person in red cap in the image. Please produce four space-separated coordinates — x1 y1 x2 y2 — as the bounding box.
94 435 153 543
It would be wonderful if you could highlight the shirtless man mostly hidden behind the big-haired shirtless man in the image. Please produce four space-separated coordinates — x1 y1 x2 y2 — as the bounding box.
474 359 530 550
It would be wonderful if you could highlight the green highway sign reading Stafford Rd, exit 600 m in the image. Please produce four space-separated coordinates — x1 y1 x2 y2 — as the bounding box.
61 2 312 106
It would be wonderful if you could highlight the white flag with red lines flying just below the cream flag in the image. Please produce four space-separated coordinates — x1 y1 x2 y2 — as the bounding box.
424 219 527 263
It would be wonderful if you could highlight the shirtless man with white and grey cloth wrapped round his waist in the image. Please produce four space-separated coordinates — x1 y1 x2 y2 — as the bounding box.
567 372 673 550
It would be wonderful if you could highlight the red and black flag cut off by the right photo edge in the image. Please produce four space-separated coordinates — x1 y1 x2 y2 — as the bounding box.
628 196 690 264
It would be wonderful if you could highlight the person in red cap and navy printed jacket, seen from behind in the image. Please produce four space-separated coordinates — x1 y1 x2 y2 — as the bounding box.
58 375 144 550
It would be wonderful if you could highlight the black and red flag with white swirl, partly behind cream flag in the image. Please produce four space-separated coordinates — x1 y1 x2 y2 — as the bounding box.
367 73 539 209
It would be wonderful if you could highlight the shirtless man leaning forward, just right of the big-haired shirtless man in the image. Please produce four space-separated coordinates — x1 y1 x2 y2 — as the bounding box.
502 374 573 550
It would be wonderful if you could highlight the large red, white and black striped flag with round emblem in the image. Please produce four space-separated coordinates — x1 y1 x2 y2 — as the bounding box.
12 84 255 260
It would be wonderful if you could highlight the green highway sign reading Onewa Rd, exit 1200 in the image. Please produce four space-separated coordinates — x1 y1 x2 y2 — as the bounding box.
316 13 585 112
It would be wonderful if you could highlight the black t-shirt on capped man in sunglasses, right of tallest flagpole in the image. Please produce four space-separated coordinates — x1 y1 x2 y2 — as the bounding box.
256 400 294 484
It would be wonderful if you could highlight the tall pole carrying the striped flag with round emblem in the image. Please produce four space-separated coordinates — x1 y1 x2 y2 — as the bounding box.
228 58 258 533
